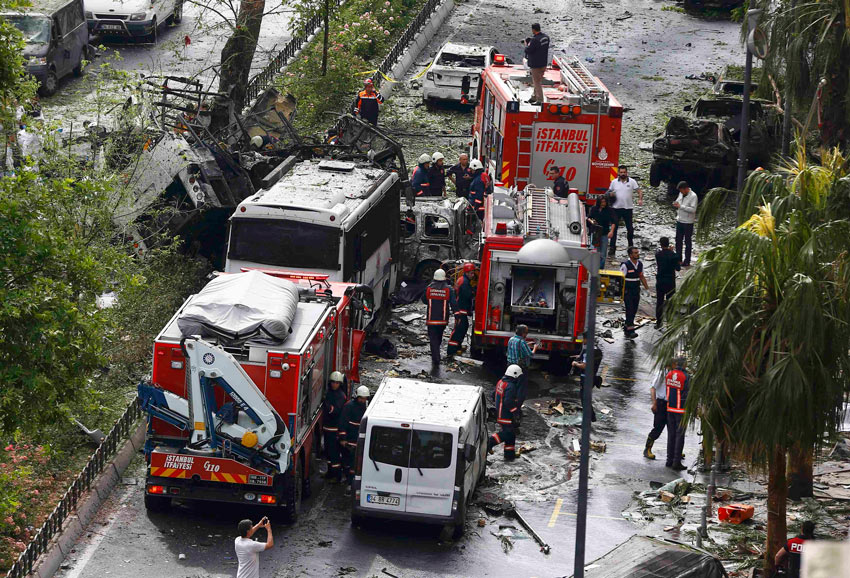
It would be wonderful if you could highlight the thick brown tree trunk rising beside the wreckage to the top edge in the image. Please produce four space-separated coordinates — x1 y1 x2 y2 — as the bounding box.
211 0 266 131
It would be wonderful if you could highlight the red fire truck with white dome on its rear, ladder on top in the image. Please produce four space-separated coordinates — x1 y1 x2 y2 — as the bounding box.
472 185 588 357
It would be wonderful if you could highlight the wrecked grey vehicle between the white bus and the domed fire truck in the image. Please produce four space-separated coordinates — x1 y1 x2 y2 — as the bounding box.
400 198 481 282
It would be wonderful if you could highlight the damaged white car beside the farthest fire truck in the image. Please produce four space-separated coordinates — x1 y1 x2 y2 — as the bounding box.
422 42 496 105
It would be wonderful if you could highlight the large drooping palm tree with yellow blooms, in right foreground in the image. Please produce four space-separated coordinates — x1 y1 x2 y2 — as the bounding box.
656 146 850 572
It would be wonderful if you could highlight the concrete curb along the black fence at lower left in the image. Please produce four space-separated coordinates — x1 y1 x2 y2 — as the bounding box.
30 420 147 578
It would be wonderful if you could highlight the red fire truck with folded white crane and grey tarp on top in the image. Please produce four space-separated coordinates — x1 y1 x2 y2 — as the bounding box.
139 270 371 519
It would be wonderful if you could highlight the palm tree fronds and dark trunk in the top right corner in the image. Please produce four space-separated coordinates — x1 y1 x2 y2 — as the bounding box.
750 0 850 146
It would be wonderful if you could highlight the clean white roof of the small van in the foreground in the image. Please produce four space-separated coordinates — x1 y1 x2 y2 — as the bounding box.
366 377 482 427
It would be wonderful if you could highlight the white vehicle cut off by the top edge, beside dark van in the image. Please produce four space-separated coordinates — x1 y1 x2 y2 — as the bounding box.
85 0 183 42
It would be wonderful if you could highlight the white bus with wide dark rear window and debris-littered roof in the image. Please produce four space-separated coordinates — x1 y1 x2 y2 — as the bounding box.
225 156 403 310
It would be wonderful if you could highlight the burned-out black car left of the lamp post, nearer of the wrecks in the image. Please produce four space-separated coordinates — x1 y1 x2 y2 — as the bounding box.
649 116 738 195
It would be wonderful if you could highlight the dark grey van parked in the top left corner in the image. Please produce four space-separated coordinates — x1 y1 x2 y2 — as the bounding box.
0 0 89 96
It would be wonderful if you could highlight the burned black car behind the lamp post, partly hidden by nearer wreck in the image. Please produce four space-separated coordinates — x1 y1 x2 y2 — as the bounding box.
685 97 782 169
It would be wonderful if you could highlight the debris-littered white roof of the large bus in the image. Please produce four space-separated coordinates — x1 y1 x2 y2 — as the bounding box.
233 159 398 224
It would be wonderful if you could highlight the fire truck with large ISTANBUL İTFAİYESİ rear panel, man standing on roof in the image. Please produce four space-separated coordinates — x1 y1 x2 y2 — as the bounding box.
470 54 623 202
